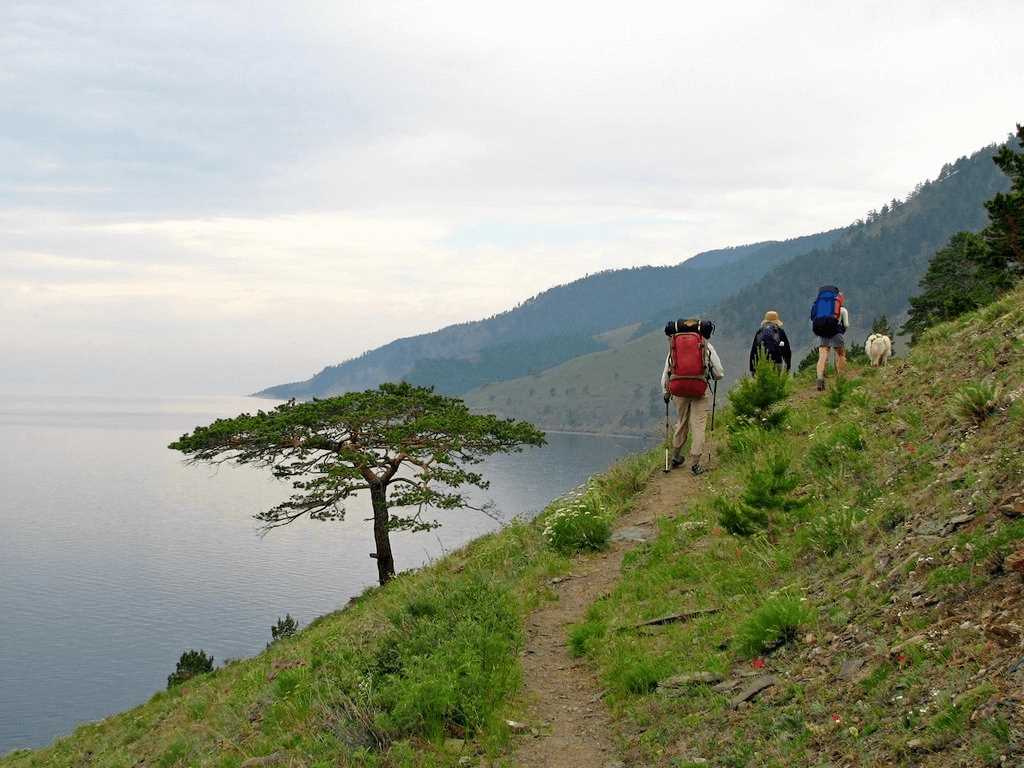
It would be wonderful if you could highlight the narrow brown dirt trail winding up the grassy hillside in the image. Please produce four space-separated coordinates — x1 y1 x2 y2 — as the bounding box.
515 468 700 768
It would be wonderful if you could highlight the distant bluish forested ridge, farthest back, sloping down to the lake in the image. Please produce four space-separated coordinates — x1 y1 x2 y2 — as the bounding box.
257 229 843 398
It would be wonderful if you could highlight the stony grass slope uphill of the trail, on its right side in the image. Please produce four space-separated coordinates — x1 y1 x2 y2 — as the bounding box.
569 288 1024 767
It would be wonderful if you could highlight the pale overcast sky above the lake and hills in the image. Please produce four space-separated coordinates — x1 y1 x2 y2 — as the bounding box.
0 0 1024 396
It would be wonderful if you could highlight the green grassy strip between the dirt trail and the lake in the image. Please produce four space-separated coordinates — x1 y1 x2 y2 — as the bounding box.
0 455 656 768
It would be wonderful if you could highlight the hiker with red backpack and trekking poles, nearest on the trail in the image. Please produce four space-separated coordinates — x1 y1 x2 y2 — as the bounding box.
662 319 725 475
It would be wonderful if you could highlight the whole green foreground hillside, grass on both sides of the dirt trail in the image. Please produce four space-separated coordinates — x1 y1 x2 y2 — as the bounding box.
0 287 1024 768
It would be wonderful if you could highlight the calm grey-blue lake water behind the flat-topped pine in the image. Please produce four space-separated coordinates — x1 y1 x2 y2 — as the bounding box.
0 397 641 754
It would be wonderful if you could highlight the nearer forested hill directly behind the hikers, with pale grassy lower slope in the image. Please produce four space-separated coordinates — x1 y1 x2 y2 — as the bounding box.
466 139 1009 433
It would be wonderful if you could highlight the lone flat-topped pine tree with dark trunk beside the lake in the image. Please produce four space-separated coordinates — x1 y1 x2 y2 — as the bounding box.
169 382 544 584
